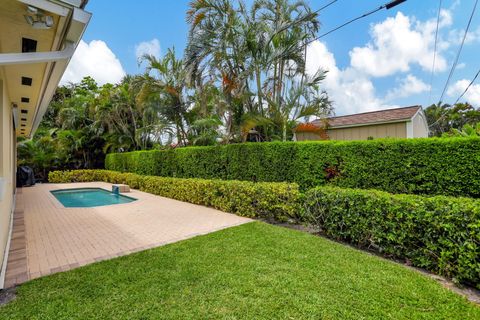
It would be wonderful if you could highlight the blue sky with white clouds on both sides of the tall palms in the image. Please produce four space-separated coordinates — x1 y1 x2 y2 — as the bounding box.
64 0 480 114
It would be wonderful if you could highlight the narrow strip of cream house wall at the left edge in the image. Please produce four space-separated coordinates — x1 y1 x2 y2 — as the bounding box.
0 74 16 288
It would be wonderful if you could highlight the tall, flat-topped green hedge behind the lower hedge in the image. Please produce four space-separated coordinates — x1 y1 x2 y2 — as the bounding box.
106 138 480 197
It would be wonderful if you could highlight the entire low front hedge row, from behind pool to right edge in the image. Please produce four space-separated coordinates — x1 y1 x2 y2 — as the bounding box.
49 170 480 288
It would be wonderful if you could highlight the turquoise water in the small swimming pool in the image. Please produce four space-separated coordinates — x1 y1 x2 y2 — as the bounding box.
51 188 137 208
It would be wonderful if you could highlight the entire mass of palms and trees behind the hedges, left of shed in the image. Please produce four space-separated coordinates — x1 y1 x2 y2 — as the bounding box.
19 0 331 179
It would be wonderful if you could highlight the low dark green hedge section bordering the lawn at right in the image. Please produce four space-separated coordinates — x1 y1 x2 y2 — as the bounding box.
305 187 480 288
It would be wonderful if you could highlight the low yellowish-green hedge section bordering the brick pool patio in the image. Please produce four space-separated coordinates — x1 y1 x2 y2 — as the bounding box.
48 170 301 221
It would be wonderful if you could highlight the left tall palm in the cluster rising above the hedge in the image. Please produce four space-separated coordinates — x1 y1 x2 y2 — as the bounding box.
185 0 254 139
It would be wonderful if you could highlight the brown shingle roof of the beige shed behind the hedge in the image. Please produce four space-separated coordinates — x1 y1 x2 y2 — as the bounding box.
313 106 421 128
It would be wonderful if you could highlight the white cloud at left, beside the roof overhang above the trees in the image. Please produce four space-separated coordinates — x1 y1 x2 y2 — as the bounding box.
60 40 125 85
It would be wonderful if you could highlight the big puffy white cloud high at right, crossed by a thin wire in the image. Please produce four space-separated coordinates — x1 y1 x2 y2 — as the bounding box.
350 10 452 77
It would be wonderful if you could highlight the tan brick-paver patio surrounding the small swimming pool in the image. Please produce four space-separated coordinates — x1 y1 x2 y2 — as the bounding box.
5 182 251 288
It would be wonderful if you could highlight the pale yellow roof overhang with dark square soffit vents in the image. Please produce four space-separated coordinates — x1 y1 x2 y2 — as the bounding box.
0 0 91 137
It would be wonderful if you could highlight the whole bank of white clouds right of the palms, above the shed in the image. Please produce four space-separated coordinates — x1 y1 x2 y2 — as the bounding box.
307 9 460 115
